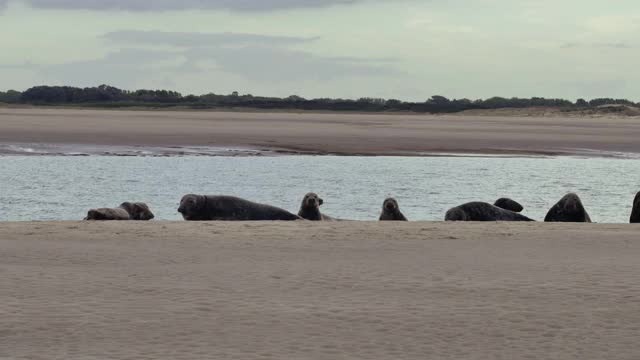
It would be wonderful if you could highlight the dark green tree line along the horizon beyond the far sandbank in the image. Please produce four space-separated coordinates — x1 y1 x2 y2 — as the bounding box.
0 85 640 113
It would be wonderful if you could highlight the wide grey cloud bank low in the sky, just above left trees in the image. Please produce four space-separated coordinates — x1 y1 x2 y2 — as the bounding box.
11 46 399 90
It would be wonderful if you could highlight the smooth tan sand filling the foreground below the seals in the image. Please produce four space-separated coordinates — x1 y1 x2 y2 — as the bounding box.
0 222 640 360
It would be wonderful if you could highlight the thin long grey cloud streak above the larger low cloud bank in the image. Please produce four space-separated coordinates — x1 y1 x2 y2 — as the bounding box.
102 30 319 47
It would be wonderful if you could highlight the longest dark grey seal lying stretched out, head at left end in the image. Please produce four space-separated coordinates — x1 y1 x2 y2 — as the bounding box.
178 194 302 221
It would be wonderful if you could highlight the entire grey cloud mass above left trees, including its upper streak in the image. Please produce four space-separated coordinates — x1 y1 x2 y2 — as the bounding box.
7 26 401 90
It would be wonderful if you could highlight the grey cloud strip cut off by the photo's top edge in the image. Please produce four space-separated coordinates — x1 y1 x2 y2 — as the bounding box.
8 0 381 12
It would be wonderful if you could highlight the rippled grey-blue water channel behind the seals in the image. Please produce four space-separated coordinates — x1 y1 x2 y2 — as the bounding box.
0 156 640 222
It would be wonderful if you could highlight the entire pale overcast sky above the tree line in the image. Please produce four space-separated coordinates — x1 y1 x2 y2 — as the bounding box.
0 0 640 101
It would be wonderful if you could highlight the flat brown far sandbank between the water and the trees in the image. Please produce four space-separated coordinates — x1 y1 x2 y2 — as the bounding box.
0 108 640 155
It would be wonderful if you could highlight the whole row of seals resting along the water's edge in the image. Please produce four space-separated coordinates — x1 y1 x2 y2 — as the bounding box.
85 192 640 223
